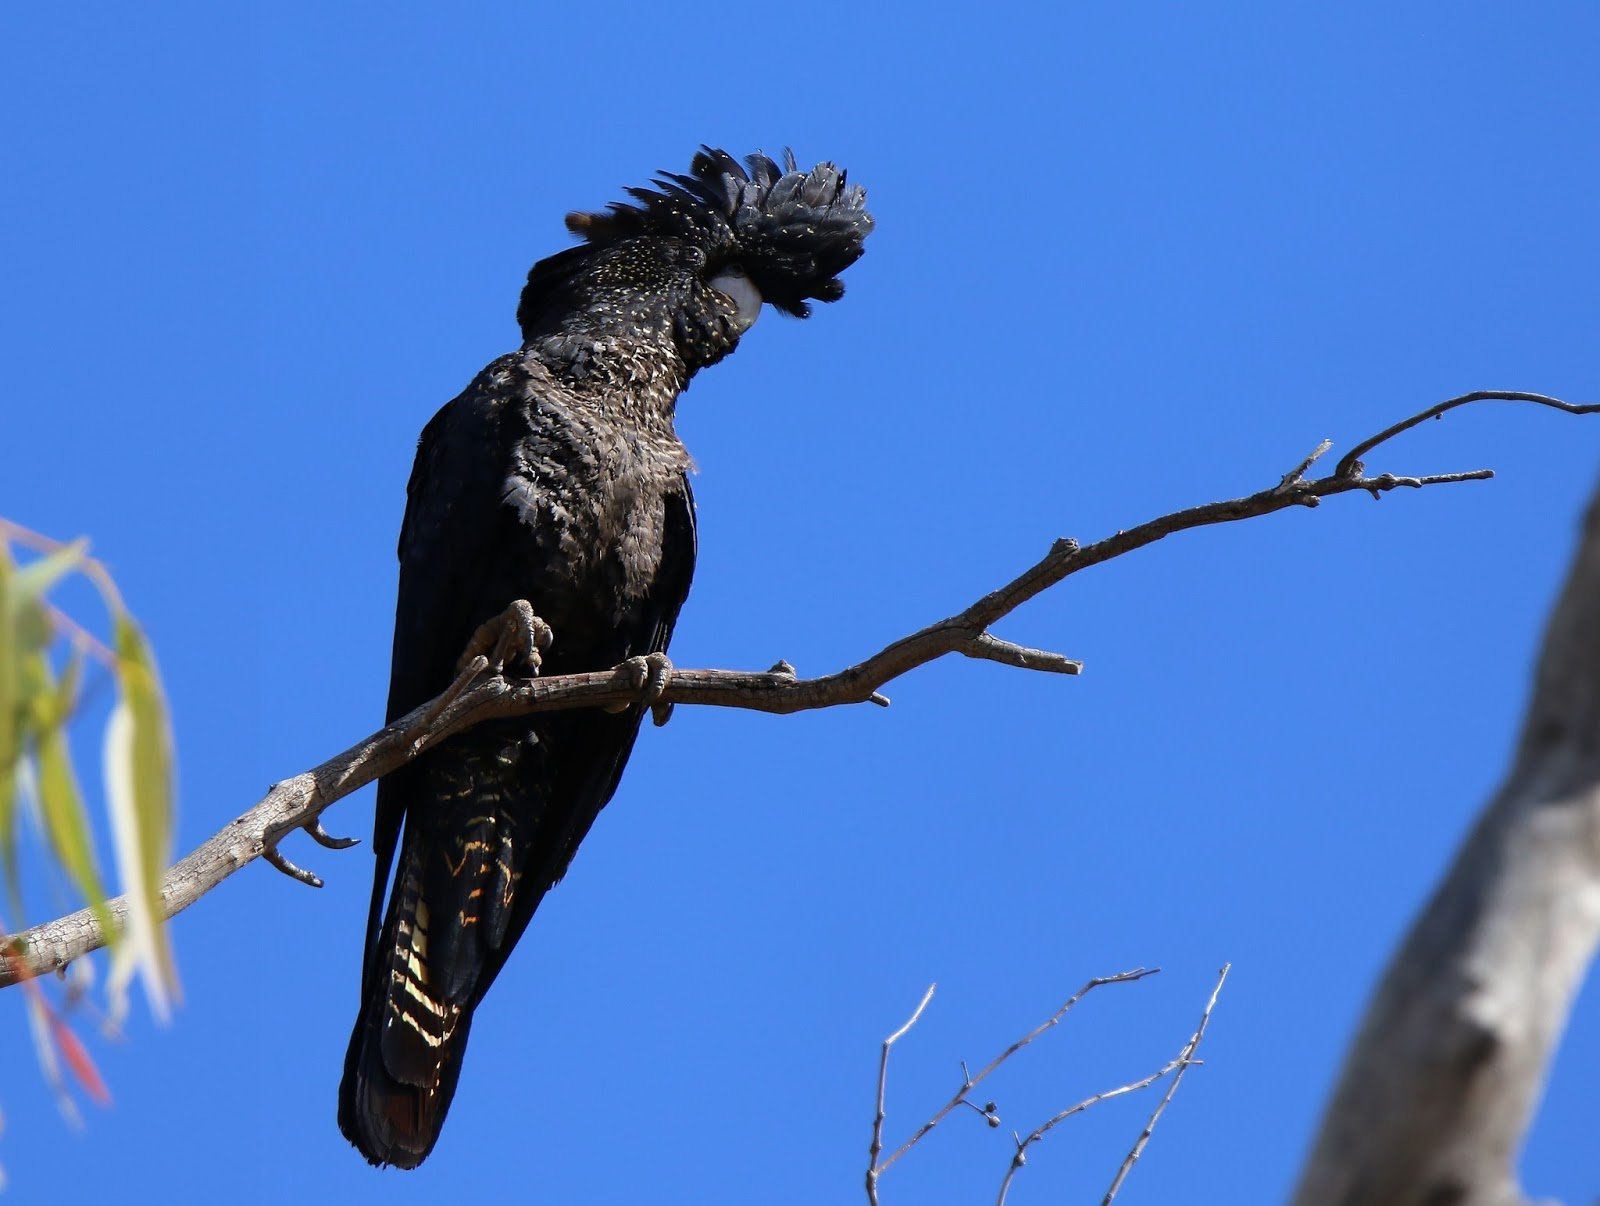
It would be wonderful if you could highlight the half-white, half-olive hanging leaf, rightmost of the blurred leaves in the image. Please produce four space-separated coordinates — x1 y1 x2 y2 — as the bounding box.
106 609 178 1019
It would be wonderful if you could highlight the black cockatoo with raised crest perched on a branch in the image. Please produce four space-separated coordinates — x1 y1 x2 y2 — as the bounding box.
339 147 872 1168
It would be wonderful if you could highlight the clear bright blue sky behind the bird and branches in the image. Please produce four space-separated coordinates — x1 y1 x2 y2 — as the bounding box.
0 0 1600 1206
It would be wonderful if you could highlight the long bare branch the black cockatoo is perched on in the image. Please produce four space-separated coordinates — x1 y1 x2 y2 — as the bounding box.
0 390 1580 987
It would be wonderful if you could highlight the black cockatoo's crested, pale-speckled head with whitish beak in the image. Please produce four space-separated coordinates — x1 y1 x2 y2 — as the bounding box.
517 147 872 373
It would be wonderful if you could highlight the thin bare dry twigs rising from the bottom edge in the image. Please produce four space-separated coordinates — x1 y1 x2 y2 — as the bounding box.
866 963 1232 1206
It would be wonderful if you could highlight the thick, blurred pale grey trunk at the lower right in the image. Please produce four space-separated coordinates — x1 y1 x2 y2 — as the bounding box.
1294 460 1600 1206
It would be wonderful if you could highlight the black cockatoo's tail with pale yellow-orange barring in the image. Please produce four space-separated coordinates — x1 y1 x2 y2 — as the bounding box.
339 799 514 1168
